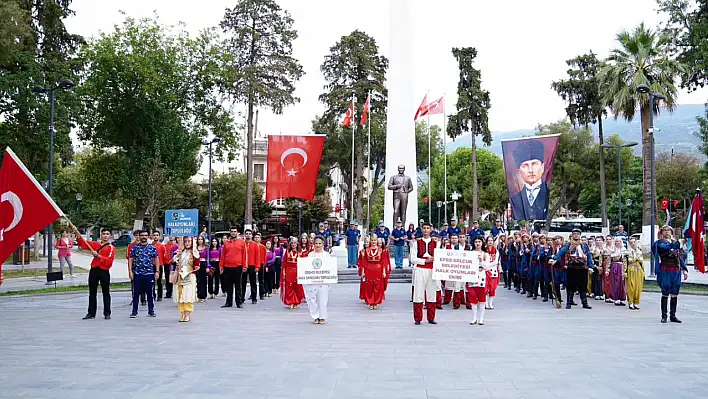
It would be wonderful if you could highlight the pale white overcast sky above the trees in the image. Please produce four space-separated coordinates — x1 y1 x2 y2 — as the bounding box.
66 0 708 173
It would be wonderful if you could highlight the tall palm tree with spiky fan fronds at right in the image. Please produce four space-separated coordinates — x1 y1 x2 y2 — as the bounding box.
598 23 685 231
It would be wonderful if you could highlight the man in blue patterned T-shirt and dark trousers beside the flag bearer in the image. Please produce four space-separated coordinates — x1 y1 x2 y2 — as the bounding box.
128 230 160 319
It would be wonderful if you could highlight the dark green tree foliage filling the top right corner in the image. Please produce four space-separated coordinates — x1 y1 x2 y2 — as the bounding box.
657 0 708 91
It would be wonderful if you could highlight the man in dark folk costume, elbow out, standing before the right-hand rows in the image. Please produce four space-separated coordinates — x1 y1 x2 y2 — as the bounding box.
549 229 593 309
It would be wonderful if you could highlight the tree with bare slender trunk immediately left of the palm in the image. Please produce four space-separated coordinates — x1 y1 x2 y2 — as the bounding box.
551 51 607 227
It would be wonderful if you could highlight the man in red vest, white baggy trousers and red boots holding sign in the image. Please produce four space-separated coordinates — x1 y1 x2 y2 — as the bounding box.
411 222 438 326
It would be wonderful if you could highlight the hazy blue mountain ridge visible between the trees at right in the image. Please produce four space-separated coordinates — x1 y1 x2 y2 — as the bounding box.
447 104 706 162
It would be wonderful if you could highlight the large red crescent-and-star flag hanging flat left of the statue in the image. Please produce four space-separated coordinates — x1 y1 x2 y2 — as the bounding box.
266 135 325 202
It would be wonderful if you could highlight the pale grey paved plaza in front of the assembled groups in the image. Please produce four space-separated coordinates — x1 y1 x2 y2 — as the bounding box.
0 284 708 399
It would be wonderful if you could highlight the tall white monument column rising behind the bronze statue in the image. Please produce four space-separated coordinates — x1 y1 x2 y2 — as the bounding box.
384 0 418 229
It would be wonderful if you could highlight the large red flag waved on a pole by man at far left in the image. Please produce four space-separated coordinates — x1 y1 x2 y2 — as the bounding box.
0 147 64 262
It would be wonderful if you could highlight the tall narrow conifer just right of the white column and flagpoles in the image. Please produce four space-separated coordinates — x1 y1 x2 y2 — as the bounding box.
447 47 492 219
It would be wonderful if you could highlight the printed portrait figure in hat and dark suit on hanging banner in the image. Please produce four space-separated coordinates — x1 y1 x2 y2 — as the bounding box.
511 140 550 220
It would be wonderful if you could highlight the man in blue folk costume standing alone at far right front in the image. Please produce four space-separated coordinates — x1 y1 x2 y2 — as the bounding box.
652 238 688 323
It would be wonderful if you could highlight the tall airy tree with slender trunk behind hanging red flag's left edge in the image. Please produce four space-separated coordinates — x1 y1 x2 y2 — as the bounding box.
220 0 303 225
